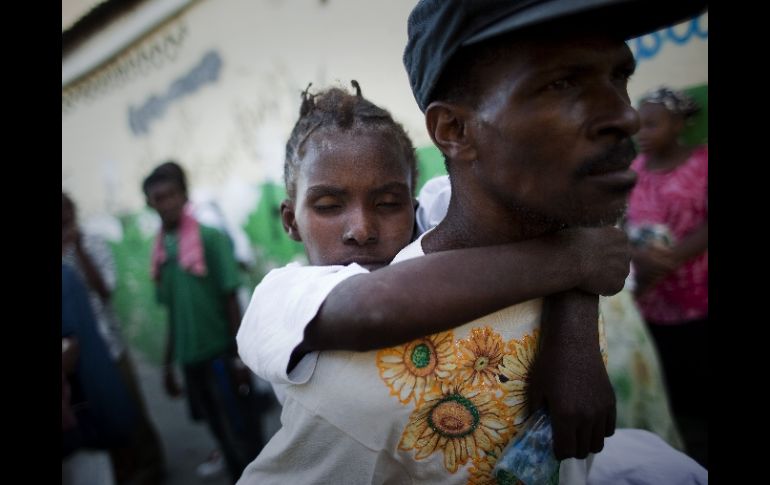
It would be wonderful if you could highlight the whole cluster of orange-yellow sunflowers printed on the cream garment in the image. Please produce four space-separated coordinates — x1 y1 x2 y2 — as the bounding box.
376 326 538 483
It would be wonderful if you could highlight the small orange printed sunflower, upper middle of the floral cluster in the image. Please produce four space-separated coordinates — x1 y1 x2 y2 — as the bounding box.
457 327 505 386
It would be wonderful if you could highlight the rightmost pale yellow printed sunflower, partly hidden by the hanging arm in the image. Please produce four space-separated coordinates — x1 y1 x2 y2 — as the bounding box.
498 330 538 426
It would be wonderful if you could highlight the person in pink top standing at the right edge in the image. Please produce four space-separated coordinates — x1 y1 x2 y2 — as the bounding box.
626 87 708 466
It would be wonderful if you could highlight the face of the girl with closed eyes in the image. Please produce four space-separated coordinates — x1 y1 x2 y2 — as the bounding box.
281 132 414 271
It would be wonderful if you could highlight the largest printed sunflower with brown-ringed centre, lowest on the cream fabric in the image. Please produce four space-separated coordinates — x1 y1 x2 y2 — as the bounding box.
398 381 510 473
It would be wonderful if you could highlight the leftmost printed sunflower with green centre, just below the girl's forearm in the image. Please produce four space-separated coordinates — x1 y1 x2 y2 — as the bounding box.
377 332 456 404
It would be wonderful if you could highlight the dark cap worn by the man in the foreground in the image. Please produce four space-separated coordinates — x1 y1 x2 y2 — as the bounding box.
404 0 708 111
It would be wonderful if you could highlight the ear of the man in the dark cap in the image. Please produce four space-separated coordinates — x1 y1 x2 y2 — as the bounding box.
425 101 476 162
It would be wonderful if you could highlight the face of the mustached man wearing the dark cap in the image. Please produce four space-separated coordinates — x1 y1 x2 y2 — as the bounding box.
473 36 639 225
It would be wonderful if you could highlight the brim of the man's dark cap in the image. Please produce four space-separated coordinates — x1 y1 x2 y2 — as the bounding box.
462 0 708 46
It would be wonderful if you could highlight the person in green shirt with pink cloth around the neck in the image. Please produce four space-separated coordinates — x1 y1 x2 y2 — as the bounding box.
142 162 263 482
